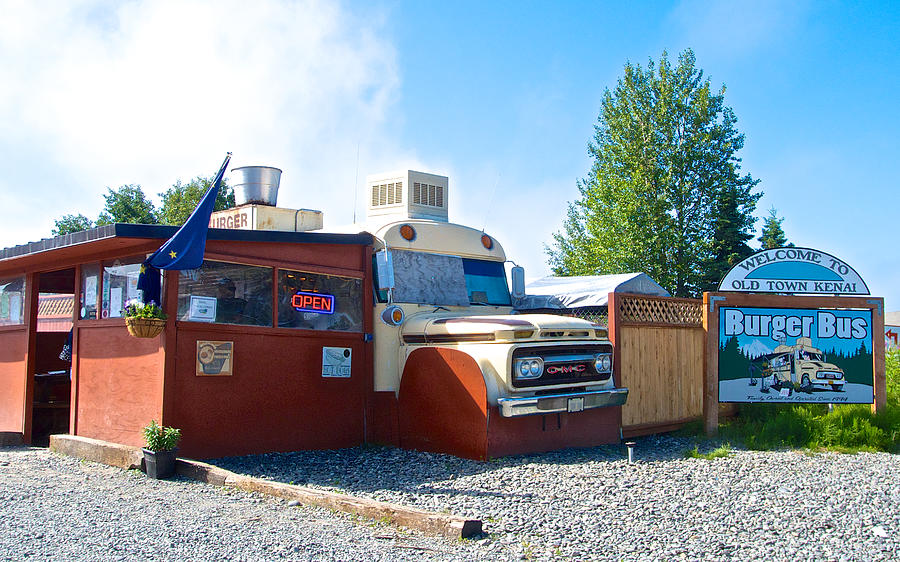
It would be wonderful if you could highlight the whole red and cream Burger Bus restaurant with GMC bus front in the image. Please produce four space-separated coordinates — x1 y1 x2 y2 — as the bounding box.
0 167 628 459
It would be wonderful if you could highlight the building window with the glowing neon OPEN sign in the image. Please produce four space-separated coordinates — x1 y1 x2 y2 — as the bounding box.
278 269 363 332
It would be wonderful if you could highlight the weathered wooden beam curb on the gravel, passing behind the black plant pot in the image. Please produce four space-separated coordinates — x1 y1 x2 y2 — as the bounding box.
50 435 481 539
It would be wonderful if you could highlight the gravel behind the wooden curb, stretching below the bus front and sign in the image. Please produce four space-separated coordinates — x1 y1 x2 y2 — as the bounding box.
213 436 900 560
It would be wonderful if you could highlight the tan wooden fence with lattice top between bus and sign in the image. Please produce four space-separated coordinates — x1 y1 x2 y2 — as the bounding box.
608 293 706 437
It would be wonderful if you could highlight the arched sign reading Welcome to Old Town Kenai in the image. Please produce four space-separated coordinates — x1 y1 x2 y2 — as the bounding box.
719 248 869 295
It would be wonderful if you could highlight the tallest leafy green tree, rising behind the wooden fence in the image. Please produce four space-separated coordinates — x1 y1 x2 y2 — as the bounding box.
547 50 759 296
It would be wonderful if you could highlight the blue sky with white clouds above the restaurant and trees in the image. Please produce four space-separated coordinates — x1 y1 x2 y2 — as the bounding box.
0 0 900 310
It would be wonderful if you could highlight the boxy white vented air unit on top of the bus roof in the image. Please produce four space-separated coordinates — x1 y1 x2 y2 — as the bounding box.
366 170 449 223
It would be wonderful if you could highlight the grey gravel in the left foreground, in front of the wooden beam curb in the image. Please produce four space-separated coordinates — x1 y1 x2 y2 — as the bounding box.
0 448 506 561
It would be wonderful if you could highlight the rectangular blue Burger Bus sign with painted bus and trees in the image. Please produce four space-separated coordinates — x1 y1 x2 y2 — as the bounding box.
718 306 874 404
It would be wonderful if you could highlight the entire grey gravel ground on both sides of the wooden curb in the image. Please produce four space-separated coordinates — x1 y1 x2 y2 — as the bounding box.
0 436 900 560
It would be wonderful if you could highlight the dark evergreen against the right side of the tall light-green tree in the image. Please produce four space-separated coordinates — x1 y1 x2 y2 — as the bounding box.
701 188 760 291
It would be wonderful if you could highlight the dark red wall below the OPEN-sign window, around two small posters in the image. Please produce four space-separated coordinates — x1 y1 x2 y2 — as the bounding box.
165 322 366 458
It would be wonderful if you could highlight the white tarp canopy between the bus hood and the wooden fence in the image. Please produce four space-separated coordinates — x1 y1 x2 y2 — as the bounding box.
516 273 672 310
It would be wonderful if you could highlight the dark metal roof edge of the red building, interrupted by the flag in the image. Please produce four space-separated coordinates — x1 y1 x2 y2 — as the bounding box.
0 223 374 261
